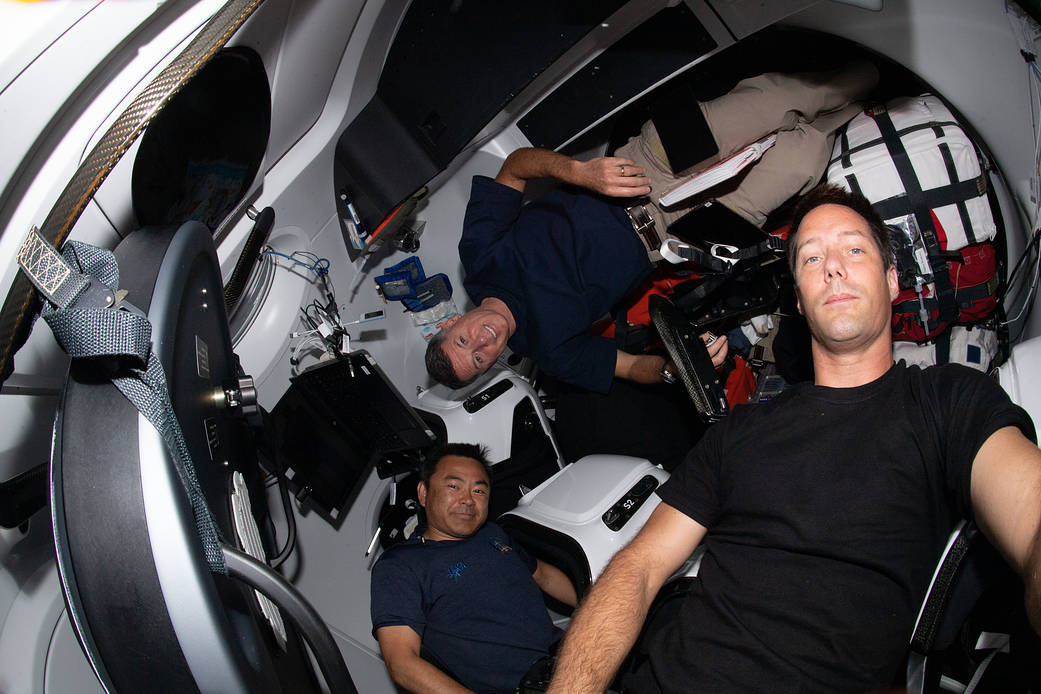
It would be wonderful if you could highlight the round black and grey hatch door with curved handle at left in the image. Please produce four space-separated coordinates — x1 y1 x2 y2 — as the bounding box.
51 223 356 693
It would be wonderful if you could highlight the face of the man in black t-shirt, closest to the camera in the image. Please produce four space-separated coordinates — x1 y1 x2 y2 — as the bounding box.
794 200 899 353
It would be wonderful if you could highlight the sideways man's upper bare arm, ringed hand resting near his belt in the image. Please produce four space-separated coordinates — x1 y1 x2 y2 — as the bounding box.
496 147 651 198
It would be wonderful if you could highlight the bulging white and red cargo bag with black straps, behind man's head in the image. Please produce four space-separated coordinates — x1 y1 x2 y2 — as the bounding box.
827 94 1000 341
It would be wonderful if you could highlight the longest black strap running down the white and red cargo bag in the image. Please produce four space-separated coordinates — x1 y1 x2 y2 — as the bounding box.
870 108 958 332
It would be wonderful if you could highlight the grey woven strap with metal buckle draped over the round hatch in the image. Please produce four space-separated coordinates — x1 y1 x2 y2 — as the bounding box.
35 236 228 574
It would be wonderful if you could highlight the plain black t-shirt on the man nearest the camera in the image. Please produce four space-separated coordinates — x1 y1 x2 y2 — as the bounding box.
650 362 1034 692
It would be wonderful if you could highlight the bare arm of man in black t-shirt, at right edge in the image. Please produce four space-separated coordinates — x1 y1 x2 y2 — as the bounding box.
971 427 1041 634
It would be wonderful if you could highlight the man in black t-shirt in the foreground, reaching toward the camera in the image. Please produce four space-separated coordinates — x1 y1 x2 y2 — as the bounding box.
550 185 1041 694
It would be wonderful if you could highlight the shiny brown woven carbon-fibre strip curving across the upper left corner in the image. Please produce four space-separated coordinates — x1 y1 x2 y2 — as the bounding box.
0 0 263 383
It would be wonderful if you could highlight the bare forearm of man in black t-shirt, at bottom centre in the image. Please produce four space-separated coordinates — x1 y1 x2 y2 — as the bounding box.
548 504 706 694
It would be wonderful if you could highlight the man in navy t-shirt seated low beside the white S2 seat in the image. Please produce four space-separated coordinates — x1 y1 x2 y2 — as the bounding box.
371 443 577 693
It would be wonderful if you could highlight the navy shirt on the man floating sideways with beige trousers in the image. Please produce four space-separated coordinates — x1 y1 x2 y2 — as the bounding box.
459 176 651 392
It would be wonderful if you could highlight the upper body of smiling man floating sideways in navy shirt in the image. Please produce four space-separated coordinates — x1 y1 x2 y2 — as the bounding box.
427 148 727 393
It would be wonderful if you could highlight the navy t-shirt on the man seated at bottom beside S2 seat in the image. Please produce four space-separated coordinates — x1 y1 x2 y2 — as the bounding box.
371 522 560 692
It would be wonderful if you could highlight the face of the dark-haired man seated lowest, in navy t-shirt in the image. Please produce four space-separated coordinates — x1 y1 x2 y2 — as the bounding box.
417 456 489 540
